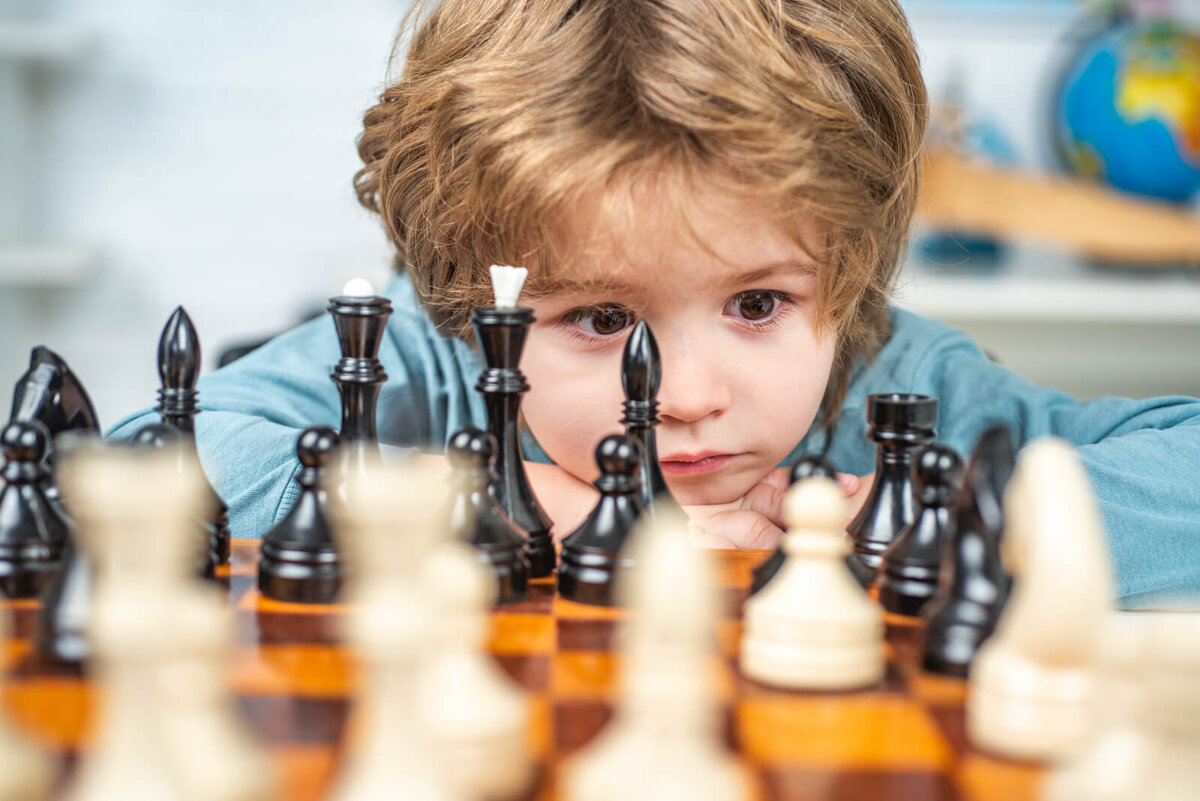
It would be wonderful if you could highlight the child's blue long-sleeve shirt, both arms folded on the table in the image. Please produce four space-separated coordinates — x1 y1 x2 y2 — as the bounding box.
109 276 1200 606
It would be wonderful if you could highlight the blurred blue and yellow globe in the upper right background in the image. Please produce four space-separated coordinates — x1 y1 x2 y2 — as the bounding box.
1055 20 1200 203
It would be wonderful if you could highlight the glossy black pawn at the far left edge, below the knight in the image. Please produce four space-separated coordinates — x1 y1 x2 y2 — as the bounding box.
0 420 68 598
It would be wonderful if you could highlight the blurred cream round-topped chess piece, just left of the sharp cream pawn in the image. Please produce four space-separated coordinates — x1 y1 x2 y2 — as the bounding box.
560 513 750 801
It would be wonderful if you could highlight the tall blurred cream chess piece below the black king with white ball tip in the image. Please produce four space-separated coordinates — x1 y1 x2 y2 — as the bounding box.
330 455 466 801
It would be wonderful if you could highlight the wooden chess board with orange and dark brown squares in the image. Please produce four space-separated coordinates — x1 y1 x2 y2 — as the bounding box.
4 540 1042 801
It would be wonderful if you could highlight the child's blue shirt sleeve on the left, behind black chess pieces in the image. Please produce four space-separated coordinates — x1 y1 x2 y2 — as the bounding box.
108 283 486 537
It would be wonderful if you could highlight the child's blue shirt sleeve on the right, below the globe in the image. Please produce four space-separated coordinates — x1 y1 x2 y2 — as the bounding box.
912 331 1200 607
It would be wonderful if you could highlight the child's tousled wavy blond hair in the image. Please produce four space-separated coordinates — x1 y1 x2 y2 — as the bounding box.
354 0 928 423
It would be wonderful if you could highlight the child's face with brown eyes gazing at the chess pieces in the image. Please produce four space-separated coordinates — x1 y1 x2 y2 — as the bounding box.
521 182 835 505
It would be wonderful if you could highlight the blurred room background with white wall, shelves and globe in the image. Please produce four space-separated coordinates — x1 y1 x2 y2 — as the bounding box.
0 0 1200 427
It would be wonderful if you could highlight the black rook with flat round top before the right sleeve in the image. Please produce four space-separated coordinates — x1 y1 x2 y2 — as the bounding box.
846 392 937 586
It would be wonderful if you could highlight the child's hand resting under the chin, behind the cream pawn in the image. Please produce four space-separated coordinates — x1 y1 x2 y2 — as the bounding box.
684 468 875 549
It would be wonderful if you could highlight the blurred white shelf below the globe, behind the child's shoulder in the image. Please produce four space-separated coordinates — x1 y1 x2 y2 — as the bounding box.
895 251 1200 325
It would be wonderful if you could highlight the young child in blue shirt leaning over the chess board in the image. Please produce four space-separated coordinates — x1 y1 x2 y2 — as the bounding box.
114 0 1200 604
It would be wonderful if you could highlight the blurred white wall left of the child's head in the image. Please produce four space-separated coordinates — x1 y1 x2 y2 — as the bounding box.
0 0 408 424
